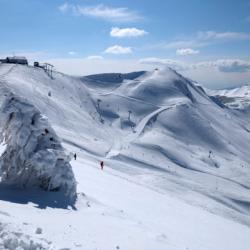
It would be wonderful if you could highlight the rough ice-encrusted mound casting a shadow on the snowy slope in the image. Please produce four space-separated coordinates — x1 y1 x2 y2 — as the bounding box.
0 94 76 198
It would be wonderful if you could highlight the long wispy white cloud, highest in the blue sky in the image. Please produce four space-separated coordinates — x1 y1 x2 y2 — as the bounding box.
59 3 142 22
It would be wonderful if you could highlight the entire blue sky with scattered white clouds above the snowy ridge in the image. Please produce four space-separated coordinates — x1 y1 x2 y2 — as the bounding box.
0 0 250 88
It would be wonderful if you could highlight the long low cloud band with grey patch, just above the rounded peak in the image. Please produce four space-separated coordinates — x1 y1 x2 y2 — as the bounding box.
139 57 250 73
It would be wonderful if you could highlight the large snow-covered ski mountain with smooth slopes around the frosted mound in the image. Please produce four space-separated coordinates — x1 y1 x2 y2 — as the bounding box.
0 64 250 250
